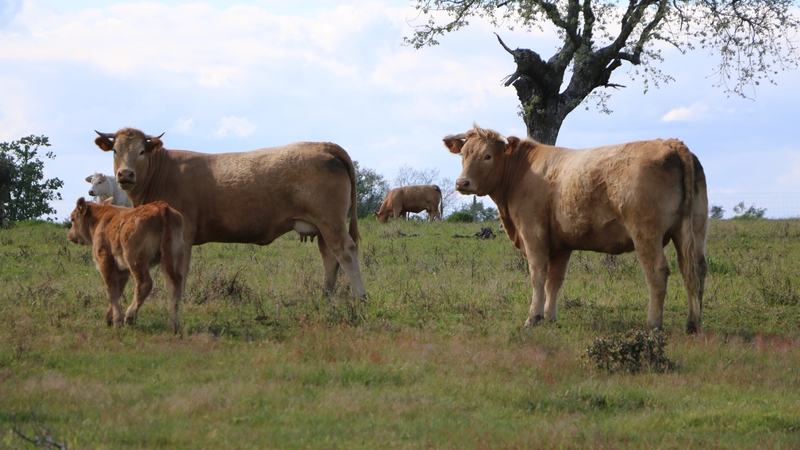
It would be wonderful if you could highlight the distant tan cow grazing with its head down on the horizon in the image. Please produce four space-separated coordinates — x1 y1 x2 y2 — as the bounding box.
374 184 442 223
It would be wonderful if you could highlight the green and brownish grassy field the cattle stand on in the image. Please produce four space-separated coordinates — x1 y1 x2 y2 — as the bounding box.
0 220 800 449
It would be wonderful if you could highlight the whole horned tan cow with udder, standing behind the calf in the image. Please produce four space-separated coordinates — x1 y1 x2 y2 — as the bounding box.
95 128 366 297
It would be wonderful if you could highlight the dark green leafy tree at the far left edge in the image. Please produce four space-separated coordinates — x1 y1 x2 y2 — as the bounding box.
0 135 64 223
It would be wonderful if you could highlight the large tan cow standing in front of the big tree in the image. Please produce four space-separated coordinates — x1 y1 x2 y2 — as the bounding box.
444 125 708 333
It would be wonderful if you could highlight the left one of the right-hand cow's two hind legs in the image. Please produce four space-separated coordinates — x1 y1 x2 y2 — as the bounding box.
633 236 669 330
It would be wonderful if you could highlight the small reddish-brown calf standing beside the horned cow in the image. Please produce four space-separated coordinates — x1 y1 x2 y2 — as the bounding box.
67 197 188 331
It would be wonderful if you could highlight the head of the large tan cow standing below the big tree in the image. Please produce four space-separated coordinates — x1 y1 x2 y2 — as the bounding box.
442 125 519 195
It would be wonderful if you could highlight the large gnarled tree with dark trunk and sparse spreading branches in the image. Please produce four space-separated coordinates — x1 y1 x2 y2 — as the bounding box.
406 0 798 144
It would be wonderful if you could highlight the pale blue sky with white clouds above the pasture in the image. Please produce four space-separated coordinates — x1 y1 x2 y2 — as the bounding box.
0 0 800 218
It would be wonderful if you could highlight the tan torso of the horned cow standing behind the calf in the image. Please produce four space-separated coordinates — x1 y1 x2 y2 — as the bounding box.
135 142 351 245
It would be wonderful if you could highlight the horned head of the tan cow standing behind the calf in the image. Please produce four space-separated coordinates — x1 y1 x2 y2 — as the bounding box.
94 128 164 191
